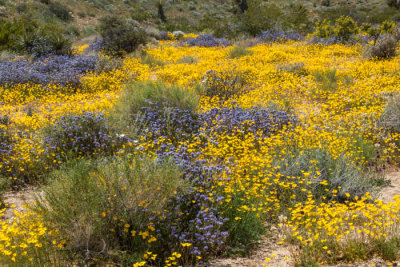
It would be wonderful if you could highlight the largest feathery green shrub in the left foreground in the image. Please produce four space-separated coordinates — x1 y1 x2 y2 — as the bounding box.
35 156 184 266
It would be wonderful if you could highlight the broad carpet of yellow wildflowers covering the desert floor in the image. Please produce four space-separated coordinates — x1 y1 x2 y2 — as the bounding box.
0 38 400 266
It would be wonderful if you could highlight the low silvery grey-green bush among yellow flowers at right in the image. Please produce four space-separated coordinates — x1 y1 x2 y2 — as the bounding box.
277 149 384 202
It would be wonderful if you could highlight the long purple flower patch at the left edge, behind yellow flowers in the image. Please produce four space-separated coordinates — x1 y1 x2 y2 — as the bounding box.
0 55 97 85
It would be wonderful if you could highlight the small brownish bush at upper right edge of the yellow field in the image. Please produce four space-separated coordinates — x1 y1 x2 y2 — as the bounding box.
364 36 397 60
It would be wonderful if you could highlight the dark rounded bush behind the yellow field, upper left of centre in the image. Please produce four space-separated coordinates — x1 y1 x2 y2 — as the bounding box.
99 16 147 55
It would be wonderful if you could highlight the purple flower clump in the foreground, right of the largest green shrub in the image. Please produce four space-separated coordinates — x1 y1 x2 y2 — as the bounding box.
157 188 228 259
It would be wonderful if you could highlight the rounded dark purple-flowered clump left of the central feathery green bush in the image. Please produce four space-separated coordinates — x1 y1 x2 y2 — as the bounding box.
44 112 127 162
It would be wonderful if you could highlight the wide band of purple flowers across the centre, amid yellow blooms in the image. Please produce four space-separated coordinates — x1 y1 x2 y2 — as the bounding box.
133 104 297 149
